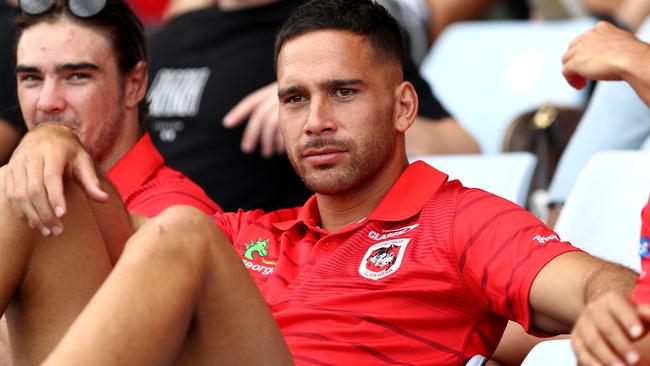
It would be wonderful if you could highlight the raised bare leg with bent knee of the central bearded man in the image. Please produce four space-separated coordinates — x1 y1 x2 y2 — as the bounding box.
45 207 293 365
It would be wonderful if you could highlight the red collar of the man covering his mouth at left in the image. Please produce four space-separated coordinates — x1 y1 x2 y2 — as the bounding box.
107 133 165 197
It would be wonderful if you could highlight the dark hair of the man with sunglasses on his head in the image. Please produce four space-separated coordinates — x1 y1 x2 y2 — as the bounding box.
16 0 149 131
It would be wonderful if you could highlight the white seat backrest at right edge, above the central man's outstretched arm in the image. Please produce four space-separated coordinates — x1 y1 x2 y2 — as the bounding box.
555 151 650 271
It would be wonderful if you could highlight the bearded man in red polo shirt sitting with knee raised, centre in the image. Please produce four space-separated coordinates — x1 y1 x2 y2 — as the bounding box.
0 0 635 365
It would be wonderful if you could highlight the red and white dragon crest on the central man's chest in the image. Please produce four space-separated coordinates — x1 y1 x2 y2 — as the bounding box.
359 239 411 280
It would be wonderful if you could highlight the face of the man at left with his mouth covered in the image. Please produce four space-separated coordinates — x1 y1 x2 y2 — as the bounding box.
16 20 125 161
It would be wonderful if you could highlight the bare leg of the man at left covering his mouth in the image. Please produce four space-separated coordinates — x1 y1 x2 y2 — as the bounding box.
0 169 130 365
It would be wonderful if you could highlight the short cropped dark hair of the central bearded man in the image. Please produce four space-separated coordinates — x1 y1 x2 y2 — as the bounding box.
275 0 404 72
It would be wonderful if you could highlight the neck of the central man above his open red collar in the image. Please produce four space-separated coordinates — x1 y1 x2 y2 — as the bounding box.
316 154 408 232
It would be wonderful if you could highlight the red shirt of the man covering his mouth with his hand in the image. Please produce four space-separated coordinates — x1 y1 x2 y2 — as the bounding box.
108 134 221 217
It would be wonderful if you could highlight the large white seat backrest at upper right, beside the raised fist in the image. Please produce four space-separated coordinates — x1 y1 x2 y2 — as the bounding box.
420 18 595 154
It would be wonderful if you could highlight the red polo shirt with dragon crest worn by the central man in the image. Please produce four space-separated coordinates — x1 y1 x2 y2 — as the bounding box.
215 162 578 365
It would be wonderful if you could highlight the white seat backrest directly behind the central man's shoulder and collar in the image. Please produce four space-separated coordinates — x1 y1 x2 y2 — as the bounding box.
409 152 537 206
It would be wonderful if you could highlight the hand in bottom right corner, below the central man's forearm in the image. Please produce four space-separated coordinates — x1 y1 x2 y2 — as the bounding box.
571 293 650 365
